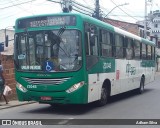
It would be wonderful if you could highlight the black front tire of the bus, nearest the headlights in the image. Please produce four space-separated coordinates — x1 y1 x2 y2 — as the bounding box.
97 86 108 106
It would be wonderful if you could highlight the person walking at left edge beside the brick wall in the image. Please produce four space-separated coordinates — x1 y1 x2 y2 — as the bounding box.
0 60 8 104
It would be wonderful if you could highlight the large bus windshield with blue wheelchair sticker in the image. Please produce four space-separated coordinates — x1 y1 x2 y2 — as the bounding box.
15 28 82 72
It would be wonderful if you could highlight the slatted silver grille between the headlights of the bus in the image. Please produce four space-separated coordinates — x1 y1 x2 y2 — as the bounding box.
22 77 70 85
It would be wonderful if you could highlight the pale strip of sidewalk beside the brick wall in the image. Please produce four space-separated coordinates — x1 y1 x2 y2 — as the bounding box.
0 100 35 110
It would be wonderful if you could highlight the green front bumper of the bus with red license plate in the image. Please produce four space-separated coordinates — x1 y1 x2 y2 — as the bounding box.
16 87 87 104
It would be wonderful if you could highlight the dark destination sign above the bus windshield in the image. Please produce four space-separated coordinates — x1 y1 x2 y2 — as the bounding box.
18 16 76 29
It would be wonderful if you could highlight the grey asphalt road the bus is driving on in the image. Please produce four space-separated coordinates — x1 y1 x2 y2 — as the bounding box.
0 76 160 128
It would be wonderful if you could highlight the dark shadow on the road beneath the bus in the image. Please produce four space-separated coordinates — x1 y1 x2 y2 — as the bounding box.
24 89 153 115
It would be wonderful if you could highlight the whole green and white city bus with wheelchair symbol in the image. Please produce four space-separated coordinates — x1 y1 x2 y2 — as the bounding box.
14 13 155 105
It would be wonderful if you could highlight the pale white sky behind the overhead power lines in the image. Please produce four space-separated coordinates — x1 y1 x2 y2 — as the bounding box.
0 0 160 29
